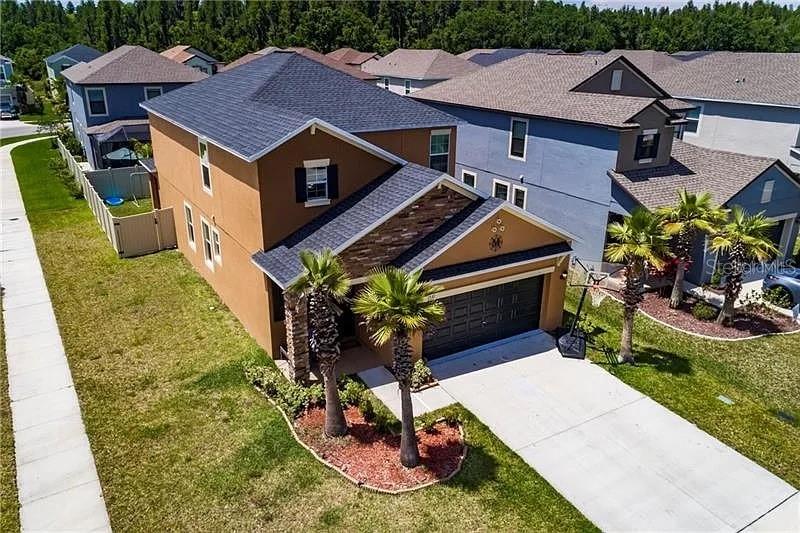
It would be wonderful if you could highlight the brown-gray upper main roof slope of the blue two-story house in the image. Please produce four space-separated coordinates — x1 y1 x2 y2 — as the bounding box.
411 54 656 127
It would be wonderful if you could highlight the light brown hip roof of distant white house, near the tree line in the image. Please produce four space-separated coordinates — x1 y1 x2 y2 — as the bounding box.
364 48 481 80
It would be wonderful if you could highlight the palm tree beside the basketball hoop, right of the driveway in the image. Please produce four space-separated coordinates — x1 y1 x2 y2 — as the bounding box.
606 207 669 363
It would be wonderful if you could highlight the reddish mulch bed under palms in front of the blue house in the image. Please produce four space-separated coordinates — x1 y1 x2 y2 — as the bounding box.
641 292 800 339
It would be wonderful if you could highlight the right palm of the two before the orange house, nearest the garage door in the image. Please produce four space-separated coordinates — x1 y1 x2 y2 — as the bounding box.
353 267 444 468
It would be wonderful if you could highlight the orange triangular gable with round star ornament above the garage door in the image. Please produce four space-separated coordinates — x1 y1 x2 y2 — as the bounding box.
425 205 565 270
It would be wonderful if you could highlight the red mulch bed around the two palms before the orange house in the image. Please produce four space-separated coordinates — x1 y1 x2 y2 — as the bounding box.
294 407 465 491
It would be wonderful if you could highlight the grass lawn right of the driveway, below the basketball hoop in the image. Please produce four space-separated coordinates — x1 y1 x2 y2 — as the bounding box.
567 289 800 486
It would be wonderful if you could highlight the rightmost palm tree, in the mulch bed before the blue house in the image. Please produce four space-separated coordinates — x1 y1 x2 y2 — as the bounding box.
711 205 778 326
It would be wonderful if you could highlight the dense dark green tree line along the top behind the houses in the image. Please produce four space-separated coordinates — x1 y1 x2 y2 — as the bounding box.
0 0 800 79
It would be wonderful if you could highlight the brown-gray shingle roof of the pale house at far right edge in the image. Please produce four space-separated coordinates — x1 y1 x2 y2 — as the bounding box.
652 52 800 106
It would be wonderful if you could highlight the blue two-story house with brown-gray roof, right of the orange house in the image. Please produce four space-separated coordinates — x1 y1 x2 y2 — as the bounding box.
413 54 798 278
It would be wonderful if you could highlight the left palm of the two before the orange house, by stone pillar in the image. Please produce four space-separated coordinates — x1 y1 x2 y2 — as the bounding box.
289 250 350 437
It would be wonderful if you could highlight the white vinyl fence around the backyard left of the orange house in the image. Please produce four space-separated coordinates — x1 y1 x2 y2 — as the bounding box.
56 138 178 257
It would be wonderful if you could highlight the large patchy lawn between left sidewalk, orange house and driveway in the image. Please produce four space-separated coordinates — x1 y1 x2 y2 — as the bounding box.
12 138 594 531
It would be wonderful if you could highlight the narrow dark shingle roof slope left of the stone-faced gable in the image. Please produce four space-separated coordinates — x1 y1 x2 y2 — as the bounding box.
253 163 444 286
